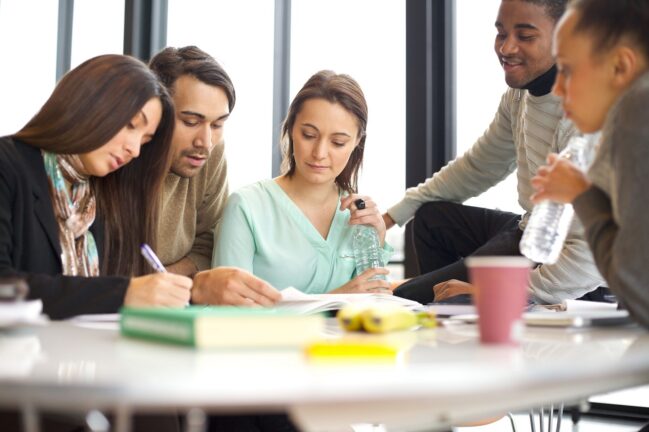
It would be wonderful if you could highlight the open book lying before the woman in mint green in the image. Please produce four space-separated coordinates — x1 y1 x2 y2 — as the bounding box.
275 287 423 314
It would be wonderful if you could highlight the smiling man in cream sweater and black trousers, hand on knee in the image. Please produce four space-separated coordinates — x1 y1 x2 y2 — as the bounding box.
383 0 604 303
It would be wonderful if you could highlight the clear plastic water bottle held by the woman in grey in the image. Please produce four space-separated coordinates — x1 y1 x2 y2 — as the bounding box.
520 135 594 264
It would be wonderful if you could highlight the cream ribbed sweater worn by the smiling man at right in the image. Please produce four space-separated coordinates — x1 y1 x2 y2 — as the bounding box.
388 89 604 303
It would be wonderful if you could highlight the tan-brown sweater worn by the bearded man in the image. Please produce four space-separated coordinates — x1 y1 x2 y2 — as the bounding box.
157 144 228 271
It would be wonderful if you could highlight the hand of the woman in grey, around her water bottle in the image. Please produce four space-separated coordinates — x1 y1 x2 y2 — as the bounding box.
530 153 590 204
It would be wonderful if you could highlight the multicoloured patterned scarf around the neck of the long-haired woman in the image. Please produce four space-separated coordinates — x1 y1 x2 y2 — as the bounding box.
43 151 99 276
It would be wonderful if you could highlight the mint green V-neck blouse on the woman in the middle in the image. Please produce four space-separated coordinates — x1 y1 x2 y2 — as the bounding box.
212 180 393 294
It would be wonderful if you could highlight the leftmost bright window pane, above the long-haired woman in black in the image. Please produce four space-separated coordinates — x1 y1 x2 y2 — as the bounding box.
0 0 58 136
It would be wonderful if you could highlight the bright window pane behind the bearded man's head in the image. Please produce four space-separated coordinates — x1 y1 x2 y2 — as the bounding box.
167 0 274 190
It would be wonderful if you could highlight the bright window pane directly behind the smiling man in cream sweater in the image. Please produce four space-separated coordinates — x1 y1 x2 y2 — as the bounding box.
455 0 523 213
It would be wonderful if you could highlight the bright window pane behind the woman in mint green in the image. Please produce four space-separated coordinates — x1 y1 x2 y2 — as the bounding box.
290 0 406 259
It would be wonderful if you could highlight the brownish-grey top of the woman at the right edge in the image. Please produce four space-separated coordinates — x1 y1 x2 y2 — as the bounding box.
573 73 649 327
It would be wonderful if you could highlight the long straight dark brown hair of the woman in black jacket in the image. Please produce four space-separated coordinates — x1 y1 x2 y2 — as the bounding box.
14 55 174 276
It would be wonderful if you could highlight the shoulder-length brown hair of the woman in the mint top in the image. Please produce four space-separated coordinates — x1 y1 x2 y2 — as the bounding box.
281 70 368 193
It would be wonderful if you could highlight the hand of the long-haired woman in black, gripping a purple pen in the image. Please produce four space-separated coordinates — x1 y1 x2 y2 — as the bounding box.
124 273 192 307
